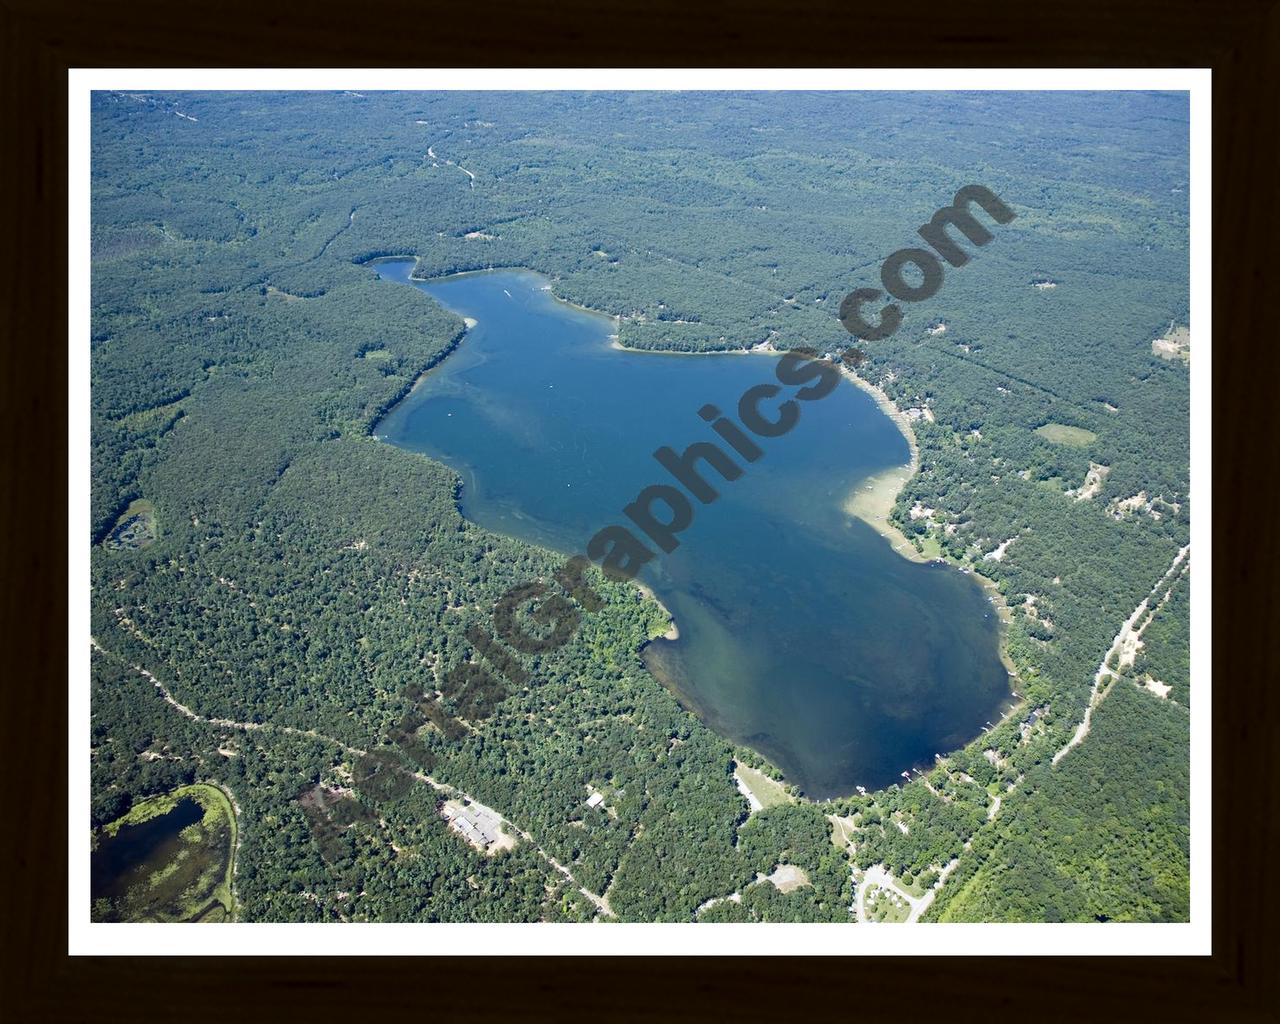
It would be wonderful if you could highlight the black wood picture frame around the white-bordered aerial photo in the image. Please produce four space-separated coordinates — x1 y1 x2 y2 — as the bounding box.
0 0 1280 1021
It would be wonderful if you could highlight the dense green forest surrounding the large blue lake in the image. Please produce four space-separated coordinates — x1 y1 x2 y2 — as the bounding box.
86 85 1194 920
